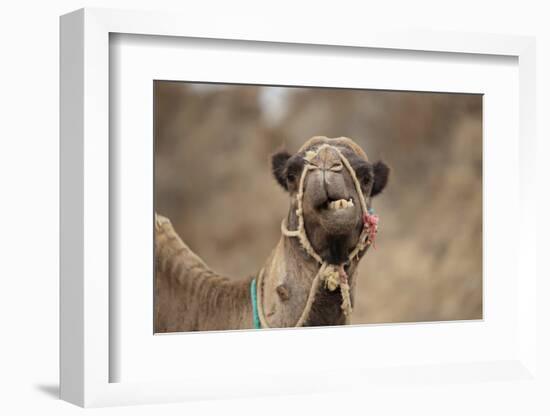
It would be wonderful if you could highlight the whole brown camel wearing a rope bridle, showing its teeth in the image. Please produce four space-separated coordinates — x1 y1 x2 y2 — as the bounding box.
154 136 389 333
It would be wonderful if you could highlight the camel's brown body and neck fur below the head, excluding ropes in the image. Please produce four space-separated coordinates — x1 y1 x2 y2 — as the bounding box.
155 216 354 333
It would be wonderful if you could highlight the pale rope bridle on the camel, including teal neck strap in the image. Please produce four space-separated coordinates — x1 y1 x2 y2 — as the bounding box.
251 144 378 328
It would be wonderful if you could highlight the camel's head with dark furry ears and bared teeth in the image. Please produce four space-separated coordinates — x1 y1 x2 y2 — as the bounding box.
272 136 389 264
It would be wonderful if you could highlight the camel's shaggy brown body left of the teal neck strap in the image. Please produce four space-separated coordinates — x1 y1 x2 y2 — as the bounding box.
155 216 252 332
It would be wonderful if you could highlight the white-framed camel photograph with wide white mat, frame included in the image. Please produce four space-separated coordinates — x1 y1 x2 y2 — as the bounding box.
61 9 536 406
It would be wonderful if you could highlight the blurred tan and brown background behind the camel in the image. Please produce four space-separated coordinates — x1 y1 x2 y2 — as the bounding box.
155 81 482 324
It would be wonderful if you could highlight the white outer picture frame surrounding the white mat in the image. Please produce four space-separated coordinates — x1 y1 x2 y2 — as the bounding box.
60 9 537 406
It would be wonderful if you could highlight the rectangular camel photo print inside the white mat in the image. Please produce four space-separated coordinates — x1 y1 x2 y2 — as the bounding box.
153 81 483 333
